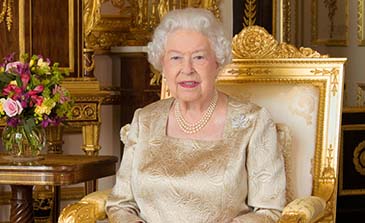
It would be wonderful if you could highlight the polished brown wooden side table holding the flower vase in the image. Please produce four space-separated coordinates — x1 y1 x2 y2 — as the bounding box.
0 154 118 223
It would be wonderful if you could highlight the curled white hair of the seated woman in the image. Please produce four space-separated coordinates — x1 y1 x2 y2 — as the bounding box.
147 8 231 71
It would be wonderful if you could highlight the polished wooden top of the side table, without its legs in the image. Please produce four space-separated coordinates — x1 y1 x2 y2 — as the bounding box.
0 154 117 186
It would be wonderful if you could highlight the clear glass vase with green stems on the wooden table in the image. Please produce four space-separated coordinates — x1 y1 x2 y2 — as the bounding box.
2 125 46 162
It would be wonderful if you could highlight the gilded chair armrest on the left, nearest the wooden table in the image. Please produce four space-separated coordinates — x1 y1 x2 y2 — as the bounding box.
58 189 111 223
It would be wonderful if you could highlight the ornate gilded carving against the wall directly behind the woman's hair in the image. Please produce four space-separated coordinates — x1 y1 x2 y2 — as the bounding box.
83 0 220 50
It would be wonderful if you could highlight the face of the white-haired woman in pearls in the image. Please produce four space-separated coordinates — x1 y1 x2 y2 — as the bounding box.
162 29 218 102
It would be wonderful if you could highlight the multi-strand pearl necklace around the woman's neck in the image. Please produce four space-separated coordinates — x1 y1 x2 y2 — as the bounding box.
175 91 218 134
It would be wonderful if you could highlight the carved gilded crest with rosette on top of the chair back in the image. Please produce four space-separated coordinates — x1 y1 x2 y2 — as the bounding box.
232 26 328 59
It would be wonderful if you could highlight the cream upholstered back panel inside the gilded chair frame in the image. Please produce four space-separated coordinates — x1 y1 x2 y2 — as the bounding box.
219 83 319 200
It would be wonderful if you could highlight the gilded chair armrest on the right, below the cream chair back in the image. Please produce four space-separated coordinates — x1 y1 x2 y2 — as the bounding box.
279 196 326 223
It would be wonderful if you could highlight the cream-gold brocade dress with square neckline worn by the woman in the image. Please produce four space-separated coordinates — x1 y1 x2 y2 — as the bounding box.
106 97 285 223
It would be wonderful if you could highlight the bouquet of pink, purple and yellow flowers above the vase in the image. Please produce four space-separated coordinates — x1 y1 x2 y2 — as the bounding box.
0 53 73 156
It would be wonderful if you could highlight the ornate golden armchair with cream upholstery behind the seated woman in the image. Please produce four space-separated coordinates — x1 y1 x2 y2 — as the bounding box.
59 26 346 223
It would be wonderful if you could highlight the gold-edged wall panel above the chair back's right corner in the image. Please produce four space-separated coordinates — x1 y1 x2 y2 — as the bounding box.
312 0 349 46
